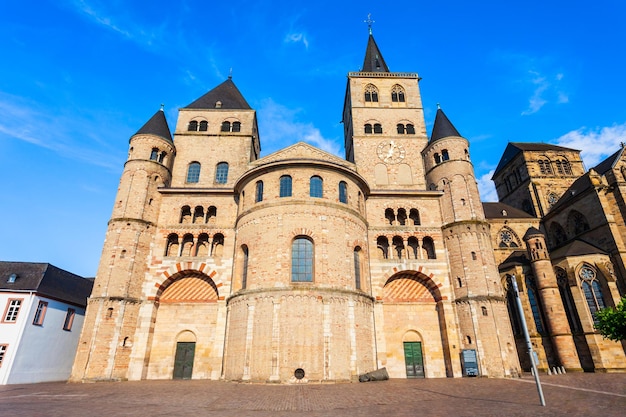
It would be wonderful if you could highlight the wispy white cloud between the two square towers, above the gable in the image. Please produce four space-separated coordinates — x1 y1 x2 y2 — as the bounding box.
258 99 340 156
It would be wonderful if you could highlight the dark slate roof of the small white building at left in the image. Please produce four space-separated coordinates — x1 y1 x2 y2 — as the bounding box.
0 261 93 307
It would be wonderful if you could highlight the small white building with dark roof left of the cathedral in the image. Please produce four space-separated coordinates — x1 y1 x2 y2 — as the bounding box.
0 262 93 385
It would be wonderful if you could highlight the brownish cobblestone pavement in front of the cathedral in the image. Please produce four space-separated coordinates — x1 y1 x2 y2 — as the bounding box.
0 374 626 417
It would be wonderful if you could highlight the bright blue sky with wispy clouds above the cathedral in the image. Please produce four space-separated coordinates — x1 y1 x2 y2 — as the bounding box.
0 0 626 276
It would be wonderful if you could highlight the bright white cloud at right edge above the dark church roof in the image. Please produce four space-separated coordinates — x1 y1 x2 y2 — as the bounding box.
555 123 626 168
